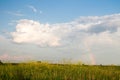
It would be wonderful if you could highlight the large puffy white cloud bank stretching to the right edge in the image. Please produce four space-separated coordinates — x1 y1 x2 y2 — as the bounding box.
11 14 120 47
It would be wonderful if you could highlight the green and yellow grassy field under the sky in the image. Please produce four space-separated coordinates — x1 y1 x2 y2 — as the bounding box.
0 63 120 80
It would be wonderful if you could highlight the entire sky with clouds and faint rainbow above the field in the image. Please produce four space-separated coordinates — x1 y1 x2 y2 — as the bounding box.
0 0 120 65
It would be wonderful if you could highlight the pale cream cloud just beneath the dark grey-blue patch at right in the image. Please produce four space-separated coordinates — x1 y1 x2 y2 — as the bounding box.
84 31 120 46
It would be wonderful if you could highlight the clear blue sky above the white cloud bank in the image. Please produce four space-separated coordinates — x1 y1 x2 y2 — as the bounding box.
0 0 120 30
